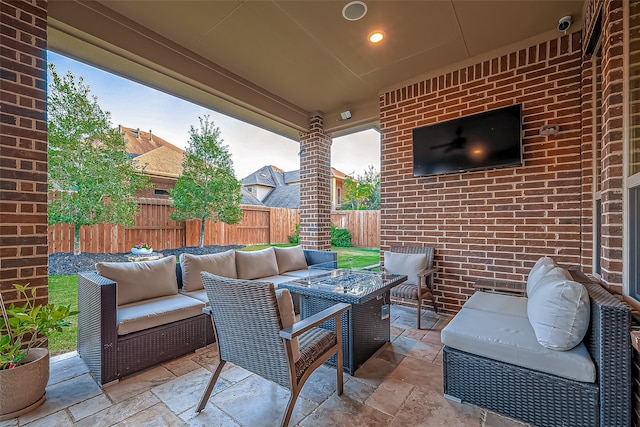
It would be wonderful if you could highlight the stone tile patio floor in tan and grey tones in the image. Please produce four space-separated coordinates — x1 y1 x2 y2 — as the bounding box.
0 305 525 427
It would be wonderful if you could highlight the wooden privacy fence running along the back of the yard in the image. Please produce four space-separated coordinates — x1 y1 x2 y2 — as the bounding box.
49 198 380 253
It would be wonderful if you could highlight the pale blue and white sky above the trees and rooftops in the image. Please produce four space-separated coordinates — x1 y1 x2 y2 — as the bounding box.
48 51 380 179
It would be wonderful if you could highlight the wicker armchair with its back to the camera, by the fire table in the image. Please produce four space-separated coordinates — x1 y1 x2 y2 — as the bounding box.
196 272 351 426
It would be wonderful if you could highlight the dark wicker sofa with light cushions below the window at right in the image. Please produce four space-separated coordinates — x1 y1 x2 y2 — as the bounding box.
442 260 631 427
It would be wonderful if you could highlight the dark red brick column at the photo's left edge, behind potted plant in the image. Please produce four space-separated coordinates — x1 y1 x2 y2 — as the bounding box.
0 0 48 308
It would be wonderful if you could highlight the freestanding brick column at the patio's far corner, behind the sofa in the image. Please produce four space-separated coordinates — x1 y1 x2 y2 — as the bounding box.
300 114 331 250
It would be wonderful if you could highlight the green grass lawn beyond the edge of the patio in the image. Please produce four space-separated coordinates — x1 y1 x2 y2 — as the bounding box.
49 244 380 356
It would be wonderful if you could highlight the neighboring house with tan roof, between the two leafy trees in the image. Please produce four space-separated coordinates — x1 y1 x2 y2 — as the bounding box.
118 126 184 197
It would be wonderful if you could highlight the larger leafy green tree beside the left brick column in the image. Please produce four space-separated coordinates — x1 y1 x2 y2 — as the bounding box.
47 64 151 255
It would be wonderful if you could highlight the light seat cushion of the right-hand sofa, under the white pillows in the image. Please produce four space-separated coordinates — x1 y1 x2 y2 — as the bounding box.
441 307 596 383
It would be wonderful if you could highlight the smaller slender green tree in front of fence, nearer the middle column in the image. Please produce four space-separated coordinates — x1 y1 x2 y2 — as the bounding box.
171 116 242 247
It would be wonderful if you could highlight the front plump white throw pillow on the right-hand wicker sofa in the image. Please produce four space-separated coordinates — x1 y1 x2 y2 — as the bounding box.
527 269 591 350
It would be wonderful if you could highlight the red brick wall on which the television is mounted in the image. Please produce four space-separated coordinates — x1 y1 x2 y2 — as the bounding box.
380 33 591 312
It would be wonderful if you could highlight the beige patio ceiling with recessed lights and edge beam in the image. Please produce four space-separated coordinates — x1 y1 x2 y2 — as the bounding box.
48 0 584 140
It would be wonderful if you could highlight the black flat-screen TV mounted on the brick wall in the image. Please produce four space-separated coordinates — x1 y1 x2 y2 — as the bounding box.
413 104 522 177
